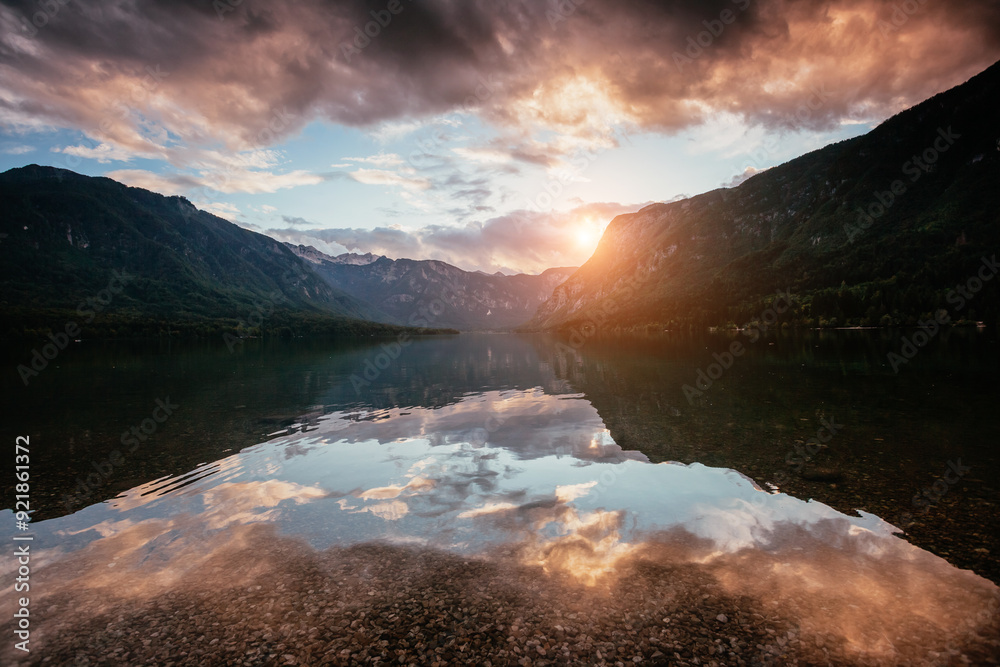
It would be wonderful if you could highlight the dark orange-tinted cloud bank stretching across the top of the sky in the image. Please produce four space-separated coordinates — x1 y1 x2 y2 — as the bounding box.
0 0 1000 167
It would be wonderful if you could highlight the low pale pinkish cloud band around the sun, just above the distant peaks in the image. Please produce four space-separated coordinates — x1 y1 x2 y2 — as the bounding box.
266 203 642 273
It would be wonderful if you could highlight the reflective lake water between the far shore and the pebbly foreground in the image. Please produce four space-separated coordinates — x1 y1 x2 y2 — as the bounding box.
0 332 1000 664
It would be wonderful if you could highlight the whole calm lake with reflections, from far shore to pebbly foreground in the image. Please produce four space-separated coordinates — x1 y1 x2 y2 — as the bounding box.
2 329 1000 664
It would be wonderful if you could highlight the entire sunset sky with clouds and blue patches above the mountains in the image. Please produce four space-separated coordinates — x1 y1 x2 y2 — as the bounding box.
0 0 1000 273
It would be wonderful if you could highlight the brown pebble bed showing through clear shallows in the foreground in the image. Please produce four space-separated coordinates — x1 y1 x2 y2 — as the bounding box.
0 526 1000 666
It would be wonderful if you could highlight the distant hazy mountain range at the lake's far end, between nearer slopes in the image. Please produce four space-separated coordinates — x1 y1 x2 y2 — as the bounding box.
289 244 576 331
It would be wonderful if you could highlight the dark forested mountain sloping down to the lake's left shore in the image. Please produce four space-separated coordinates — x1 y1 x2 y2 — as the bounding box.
0 165 442 336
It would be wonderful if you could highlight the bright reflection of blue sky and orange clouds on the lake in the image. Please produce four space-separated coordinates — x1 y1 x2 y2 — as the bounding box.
3 388 1000 663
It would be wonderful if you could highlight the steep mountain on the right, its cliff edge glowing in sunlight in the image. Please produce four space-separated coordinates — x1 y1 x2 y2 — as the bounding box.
529 63 1000 329
